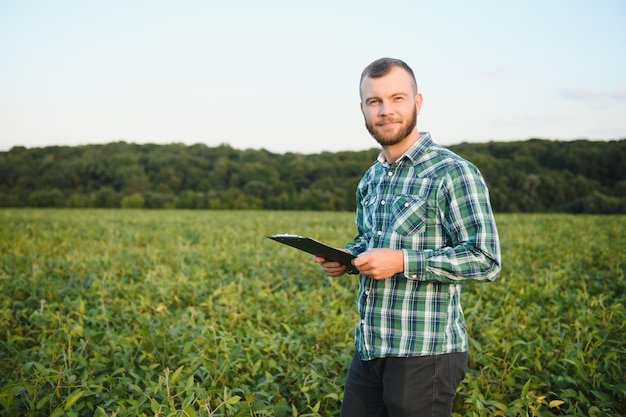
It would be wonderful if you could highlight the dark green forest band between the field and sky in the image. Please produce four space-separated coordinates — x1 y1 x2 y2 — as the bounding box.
0 139 626 214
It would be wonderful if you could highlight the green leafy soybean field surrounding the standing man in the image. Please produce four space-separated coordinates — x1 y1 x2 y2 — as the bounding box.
0 209 626 417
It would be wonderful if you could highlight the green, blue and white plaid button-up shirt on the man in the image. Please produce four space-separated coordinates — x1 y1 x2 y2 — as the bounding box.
347 133 501 360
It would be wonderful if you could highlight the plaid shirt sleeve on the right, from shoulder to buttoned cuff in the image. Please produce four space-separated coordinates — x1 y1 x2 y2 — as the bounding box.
403 163 501 283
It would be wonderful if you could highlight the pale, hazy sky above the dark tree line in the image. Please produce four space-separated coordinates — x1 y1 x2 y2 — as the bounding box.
0 0 626 154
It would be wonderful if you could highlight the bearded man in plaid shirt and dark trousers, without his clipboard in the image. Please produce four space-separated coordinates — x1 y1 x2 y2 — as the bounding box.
314 58 501 417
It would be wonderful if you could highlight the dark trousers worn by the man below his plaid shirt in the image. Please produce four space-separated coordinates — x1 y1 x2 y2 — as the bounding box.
341 352 467 417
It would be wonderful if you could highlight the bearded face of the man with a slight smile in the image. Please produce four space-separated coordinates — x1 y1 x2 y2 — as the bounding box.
361 67 422 146
